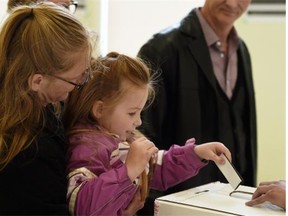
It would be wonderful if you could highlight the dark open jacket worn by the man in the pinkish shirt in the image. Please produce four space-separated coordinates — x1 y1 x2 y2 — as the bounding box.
138 10 257 214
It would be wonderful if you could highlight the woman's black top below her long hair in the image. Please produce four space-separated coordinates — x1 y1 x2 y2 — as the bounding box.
0 104 69 215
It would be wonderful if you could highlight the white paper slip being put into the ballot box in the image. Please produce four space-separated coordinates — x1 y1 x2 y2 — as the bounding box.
216 154 242 190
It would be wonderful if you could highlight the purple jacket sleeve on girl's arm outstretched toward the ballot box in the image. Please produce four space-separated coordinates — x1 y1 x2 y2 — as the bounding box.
151 142 207 191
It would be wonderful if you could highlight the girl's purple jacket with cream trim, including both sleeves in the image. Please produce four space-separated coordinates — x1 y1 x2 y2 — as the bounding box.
67 125 206 215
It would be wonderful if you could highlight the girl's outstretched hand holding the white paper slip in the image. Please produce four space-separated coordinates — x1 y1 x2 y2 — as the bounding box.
194 142 232 164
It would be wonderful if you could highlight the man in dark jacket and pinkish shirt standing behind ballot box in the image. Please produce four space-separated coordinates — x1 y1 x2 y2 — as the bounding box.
138 0 257 215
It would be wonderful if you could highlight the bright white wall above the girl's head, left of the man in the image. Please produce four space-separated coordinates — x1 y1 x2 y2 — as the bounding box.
100 0 204 55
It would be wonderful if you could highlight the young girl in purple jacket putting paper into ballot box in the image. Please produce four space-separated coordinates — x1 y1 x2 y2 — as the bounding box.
64 52 231 215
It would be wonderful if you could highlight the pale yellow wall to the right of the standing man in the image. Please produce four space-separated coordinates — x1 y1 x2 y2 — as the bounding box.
237 17 286 182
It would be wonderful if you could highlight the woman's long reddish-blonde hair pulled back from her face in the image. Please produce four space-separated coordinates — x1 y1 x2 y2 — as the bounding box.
0 2 92 170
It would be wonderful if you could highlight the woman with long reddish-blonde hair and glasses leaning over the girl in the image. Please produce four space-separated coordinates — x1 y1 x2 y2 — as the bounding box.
0 2 91 215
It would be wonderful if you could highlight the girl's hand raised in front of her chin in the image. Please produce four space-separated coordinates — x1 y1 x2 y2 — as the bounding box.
125 137 158 181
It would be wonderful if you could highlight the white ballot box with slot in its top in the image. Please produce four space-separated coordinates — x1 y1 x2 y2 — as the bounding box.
154 182 285 216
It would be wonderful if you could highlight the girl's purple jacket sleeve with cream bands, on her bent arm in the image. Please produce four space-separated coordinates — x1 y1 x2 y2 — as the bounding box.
67 145 137 215
